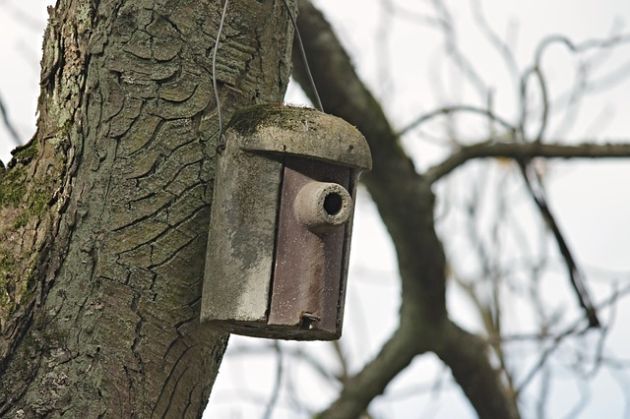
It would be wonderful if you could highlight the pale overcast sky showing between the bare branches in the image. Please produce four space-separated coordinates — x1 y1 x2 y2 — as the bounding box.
0 0 630 419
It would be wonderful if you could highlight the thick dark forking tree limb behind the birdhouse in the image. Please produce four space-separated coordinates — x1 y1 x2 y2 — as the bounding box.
293 0 518 418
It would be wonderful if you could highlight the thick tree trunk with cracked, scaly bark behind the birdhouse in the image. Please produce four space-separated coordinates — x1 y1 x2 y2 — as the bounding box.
0 0 293 418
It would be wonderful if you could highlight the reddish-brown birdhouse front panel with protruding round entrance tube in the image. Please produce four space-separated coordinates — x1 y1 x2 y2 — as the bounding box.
268 157 353 339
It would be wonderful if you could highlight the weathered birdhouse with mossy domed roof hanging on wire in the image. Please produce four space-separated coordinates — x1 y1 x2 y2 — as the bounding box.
201 105 372 340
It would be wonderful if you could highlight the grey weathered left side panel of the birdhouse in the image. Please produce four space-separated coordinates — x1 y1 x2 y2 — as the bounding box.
201 141 282 322
